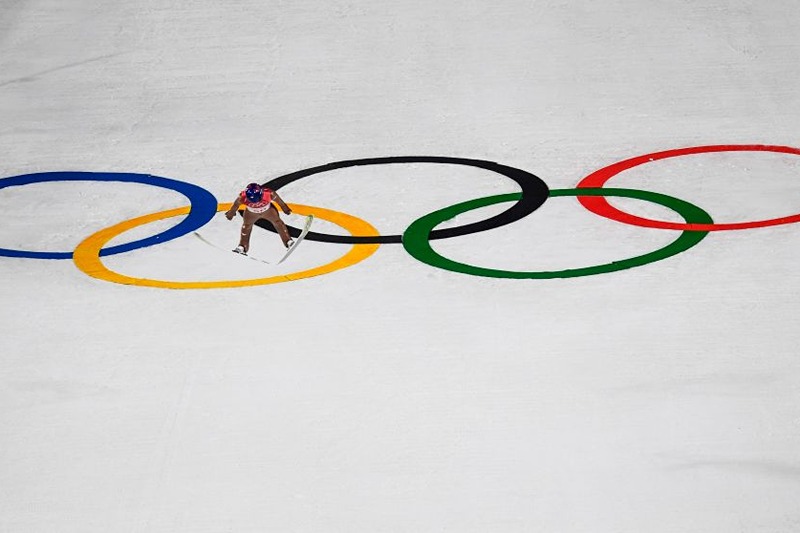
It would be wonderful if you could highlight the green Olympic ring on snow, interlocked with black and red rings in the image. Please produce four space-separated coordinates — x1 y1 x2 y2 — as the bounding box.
403 188 713 279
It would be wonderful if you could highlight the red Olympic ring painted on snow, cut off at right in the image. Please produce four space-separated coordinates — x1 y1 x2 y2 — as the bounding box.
577 144 800 231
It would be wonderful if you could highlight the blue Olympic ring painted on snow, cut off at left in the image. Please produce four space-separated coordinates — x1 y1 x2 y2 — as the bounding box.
0 172 217 259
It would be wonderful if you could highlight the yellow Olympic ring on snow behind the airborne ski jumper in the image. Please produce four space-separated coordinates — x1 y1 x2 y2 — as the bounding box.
73 203 380 289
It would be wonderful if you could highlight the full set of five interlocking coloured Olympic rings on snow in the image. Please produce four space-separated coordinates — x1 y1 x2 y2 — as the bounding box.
0 145 800 289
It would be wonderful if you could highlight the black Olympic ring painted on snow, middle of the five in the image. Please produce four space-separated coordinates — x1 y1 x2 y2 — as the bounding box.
256 156 548 244
